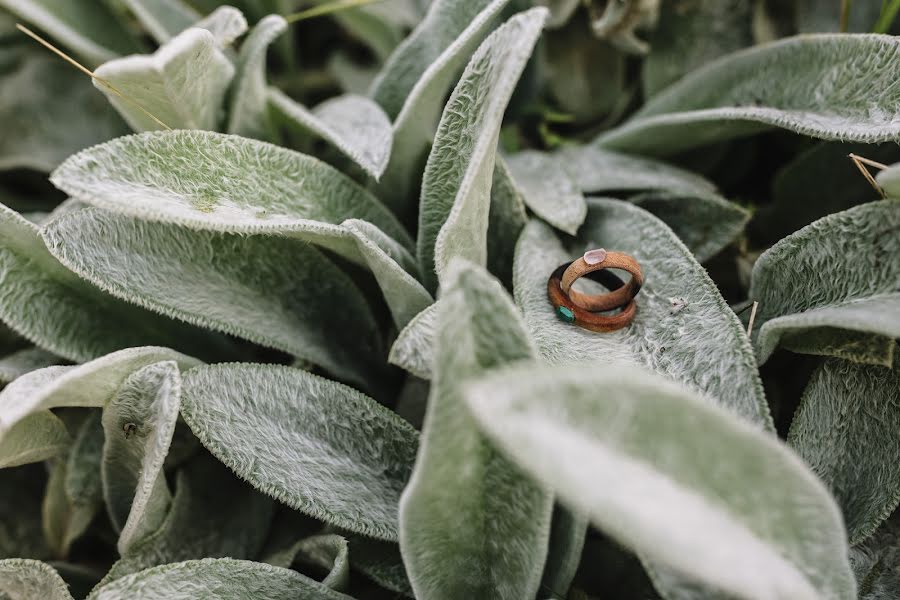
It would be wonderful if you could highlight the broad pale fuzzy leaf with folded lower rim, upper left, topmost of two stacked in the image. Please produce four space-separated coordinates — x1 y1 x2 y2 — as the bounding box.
53 131 432 330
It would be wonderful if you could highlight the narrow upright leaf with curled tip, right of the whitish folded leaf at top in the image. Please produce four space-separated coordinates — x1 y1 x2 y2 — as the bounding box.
227 15 288 141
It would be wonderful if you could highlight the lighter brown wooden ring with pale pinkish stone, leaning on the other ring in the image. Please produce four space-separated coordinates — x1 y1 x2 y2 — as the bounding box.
560 248 644 312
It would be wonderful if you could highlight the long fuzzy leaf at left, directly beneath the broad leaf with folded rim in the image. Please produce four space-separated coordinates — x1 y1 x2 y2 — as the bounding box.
43 209 380 384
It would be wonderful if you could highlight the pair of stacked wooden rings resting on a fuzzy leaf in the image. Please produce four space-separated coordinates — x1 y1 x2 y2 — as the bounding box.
547 248 644 332
